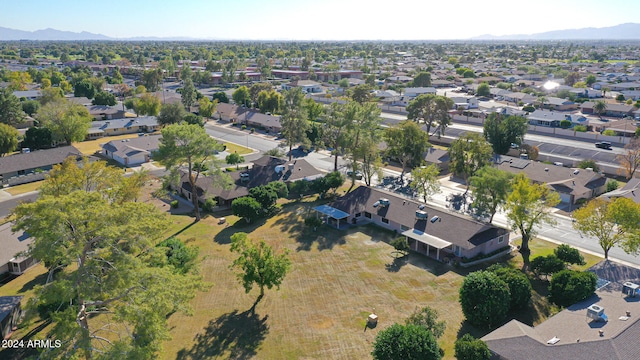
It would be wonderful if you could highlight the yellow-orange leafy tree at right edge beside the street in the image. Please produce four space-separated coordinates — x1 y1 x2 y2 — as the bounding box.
573 198 640 259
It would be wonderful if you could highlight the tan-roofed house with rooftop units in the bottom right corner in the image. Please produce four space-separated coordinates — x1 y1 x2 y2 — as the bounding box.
482 260 640 360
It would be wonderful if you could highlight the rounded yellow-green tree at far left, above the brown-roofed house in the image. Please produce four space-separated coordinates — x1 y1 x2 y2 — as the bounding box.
38 100 93 145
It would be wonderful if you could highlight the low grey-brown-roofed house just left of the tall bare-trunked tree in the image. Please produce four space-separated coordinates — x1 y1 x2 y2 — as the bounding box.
102 135 162 166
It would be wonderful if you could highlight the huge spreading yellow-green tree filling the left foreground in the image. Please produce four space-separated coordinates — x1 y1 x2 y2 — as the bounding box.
13 190 202 359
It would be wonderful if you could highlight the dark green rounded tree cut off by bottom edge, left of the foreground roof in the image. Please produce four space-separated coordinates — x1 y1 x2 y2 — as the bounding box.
371 324 442 360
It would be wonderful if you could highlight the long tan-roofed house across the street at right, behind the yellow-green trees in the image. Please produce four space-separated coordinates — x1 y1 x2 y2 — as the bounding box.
495 155 607 204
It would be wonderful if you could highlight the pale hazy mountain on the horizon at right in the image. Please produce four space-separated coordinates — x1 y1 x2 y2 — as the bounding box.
470 23 640 40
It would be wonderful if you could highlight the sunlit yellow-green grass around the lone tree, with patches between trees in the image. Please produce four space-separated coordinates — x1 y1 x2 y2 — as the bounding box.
0 190 599 360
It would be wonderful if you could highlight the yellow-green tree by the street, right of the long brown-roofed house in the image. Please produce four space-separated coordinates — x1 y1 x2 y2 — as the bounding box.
504 174 560 270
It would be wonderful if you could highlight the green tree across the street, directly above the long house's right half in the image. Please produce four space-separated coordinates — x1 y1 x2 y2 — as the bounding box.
449 132 493 190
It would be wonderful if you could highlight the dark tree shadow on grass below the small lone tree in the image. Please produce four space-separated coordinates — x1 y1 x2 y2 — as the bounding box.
177 304 269 360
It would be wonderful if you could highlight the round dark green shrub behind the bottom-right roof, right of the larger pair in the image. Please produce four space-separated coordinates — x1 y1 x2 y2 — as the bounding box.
549 270 598 307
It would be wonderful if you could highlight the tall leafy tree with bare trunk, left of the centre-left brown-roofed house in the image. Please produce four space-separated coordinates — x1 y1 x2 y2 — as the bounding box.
154 124 230 221
